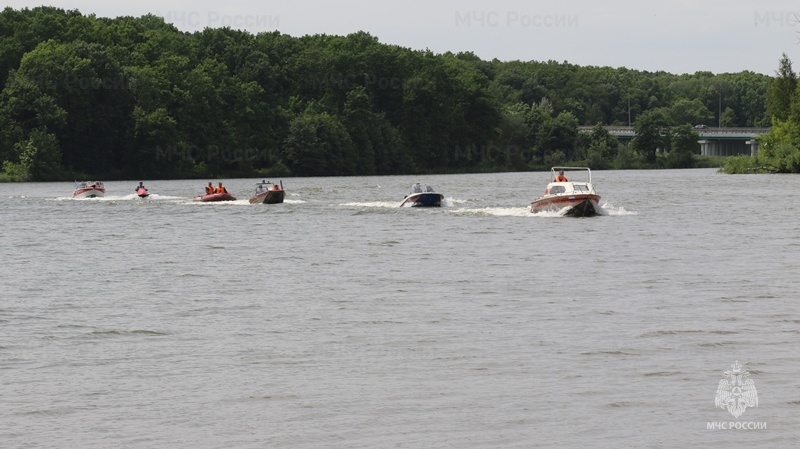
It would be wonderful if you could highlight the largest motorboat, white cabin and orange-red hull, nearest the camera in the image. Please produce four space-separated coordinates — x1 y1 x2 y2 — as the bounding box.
531 167 601 217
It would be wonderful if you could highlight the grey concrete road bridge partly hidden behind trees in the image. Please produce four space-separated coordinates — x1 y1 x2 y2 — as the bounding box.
578 126 769 156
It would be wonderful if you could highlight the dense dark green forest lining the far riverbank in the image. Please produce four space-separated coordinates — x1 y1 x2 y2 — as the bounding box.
0 7 776 180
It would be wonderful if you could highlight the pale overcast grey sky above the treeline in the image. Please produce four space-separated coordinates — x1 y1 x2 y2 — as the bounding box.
4 0 800 75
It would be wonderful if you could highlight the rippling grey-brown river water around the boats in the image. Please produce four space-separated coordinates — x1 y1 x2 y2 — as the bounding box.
0 169 800 449
